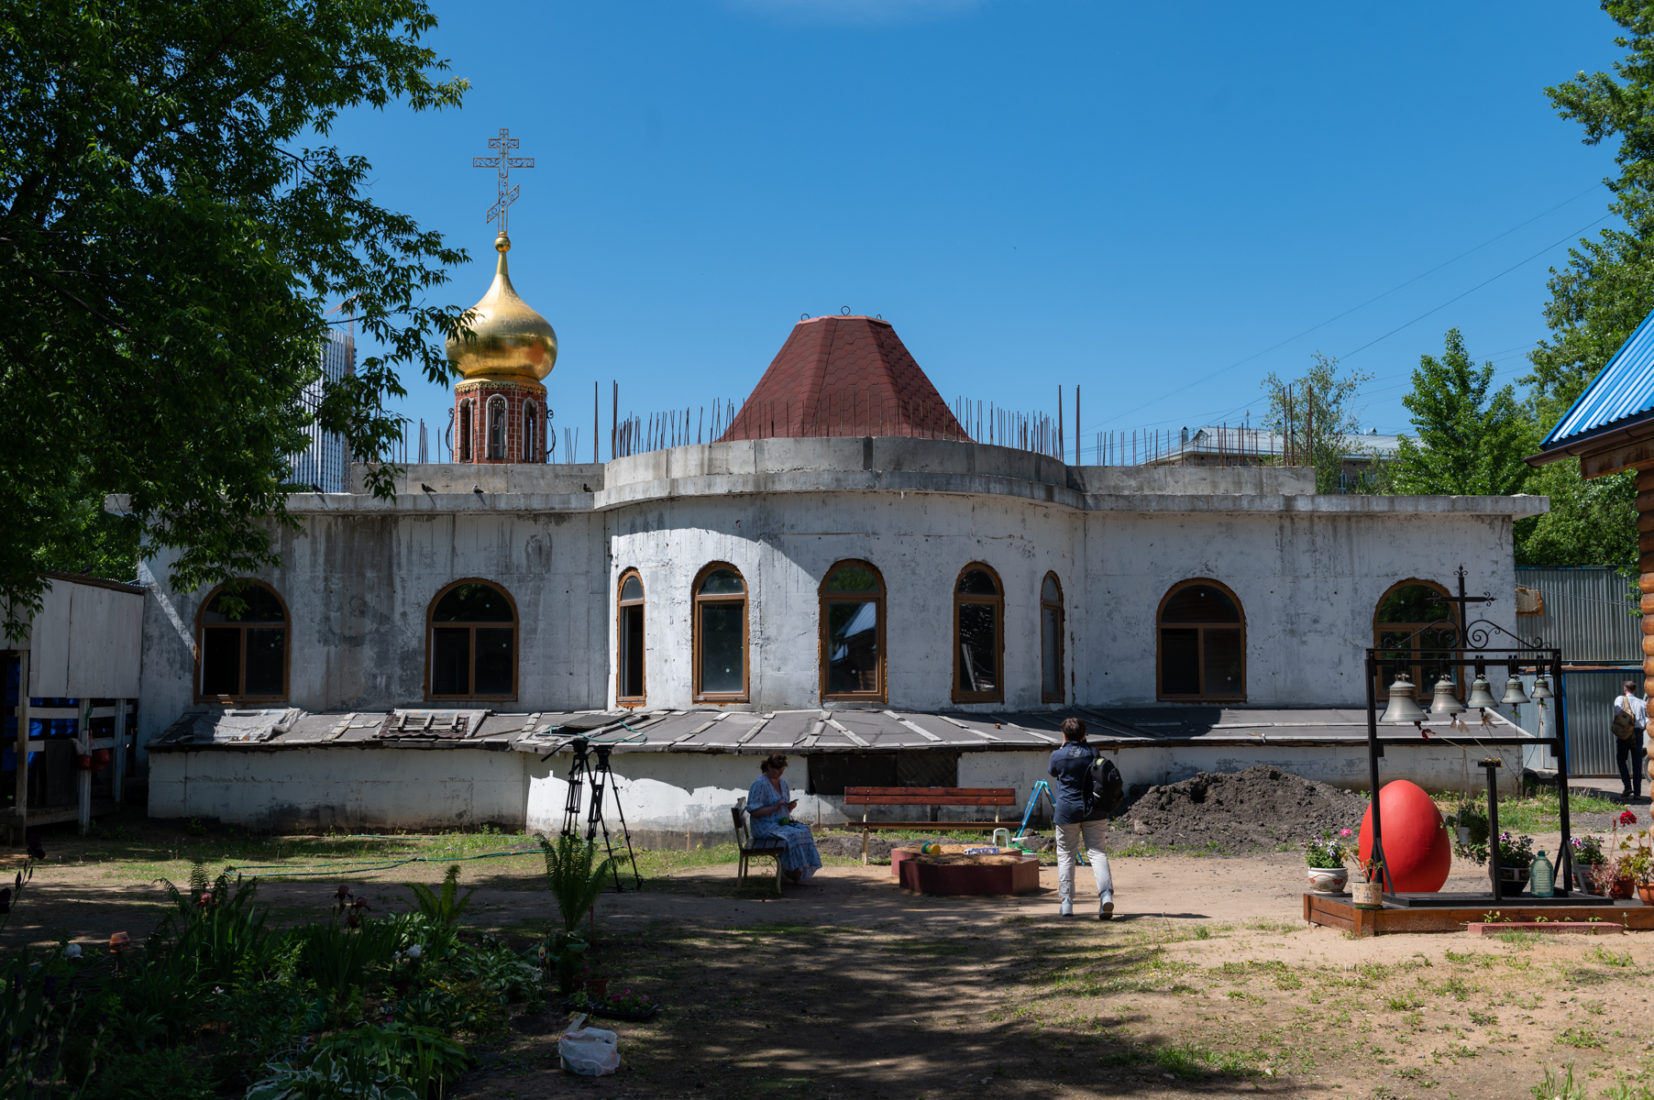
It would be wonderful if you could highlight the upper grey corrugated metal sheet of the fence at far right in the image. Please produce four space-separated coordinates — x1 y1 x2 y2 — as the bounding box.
1517 566 1642 665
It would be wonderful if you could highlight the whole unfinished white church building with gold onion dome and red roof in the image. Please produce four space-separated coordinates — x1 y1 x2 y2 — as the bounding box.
139 229 1545 833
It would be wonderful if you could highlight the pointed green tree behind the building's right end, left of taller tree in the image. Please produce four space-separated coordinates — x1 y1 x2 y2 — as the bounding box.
1391 329 1533 496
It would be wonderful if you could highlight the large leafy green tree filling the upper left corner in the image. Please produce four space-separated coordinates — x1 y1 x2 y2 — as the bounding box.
0 0 465 632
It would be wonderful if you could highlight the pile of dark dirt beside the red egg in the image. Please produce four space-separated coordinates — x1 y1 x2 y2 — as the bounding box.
1111 766 1368 855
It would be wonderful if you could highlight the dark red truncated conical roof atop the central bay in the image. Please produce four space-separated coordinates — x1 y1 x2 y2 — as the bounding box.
719 316 969 443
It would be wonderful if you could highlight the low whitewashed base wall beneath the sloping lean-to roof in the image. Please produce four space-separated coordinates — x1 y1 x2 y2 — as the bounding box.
149 743 1522 847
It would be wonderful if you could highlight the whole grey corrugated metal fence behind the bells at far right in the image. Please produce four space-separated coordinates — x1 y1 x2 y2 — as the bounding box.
1517 566 1642 776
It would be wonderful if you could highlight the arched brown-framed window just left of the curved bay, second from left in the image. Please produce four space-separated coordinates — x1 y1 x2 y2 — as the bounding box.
425 581 516 700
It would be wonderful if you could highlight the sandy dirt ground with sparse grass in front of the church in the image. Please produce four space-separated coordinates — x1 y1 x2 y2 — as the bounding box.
0 764 1654 1100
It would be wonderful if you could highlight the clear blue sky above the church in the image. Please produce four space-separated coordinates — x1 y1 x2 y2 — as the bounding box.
332 0 1618 460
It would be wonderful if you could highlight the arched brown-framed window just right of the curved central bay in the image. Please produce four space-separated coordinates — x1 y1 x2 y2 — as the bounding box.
1158 581 1245 701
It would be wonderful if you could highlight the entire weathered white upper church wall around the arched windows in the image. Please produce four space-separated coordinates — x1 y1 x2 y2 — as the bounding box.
139 438 1545 741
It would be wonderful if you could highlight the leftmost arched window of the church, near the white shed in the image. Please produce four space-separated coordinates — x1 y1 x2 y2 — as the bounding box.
195 581 288 703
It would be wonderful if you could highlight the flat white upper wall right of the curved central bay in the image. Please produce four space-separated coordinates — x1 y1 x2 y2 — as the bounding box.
1075 511 1515 706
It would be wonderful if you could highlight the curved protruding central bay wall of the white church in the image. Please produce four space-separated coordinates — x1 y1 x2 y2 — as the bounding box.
604 491 1080 711
